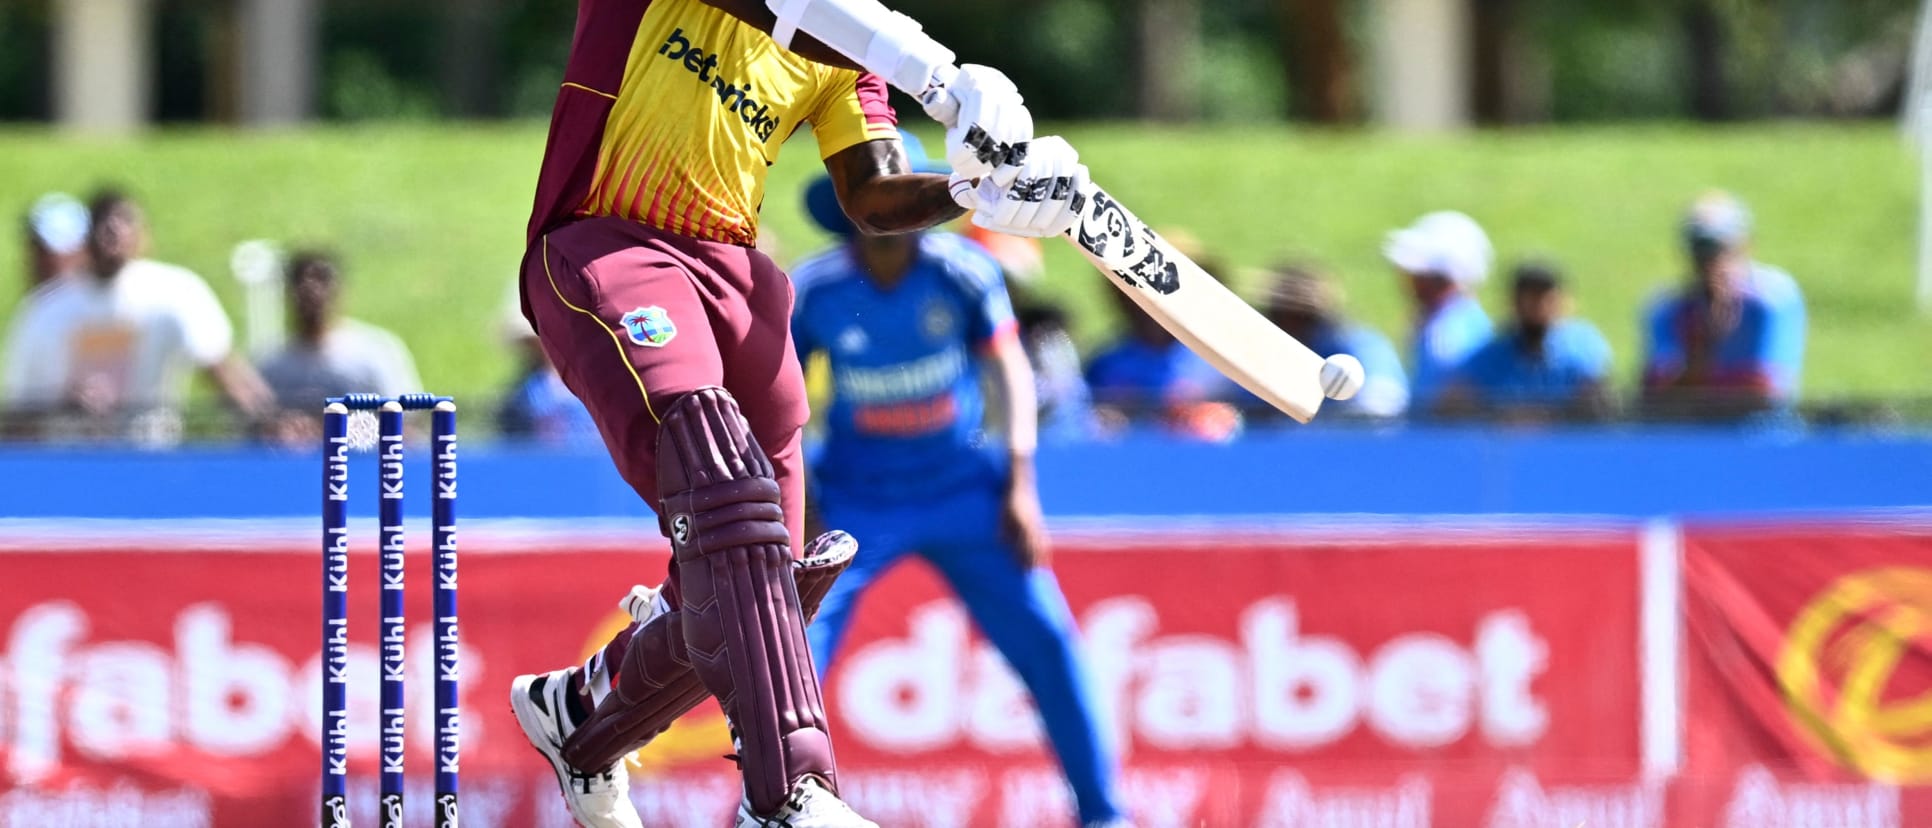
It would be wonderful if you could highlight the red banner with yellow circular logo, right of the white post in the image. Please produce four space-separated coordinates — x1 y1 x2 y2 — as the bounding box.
1677 525 1932 826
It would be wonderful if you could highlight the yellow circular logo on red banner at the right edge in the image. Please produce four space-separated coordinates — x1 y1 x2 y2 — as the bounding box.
1777 567 1932 784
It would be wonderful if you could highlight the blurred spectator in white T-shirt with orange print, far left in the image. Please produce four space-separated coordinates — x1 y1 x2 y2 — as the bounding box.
6 191 270 442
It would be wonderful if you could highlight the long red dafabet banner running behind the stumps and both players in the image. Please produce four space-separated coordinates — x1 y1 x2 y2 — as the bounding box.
0 527 1665 828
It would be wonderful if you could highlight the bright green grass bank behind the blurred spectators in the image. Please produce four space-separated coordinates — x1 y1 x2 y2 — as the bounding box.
0 124 1932 400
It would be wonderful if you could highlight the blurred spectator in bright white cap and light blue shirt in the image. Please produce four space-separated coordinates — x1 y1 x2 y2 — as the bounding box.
1381 210 1495 411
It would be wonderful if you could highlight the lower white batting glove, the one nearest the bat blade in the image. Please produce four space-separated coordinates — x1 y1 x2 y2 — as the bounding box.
952 135 1090 237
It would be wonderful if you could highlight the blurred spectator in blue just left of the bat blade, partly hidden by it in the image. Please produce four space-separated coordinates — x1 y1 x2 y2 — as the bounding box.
1086 230 1240 440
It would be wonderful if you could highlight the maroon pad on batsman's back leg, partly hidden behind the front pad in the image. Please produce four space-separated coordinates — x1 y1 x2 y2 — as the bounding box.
564 533 858 772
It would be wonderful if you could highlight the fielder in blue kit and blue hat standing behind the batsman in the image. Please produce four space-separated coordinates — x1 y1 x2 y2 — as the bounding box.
792 137 1124 824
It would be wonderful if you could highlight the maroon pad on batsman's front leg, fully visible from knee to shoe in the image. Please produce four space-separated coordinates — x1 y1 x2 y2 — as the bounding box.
657 388 837 814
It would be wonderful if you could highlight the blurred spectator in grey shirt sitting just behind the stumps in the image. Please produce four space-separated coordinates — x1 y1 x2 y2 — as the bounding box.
261 251 423 444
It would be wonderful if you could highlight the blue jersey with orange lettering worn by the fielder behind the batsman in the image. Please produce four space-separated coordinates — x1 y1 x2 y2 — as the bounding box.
792 234 1016 498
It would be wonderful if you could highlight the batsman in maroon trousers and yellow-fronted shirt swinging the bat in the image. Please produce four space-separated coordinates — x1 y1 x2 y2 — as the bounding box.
510 0 1088 828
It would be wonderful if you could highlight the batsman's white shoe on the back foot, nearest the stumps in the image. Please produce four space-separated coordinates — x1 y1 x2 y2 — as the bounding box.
510 668 643 828
